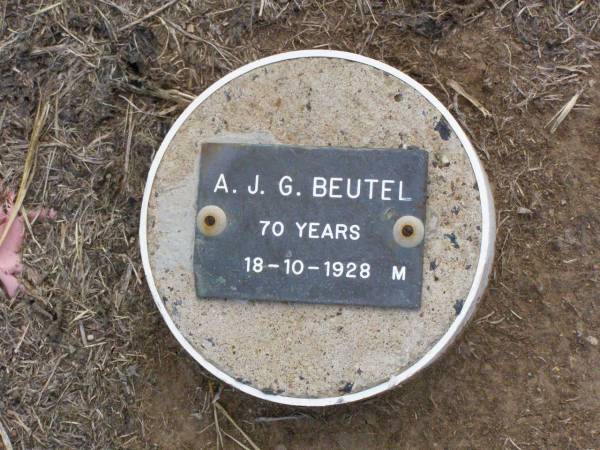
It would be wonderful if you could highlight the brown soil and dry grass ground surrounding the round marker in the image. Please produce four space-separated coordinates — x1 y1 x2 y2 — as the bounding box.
0 0 600 450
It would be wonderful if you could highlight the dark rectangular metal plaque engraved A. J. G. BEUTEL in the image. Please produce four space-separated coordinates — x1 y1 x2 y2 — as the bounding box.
194 143 427 309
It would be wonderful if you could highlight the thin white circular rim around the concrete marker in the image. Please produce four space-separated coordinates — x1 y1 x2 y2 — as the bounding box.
140 50 496 406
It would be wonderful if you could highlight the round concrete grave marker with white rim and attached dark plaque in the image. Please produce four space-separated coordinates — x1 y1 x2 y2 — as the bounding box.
140 50 495 406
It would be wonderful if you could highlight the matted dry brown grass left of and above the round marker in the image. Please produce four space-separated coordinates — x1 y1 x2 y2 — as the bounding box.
0 0 600 449
